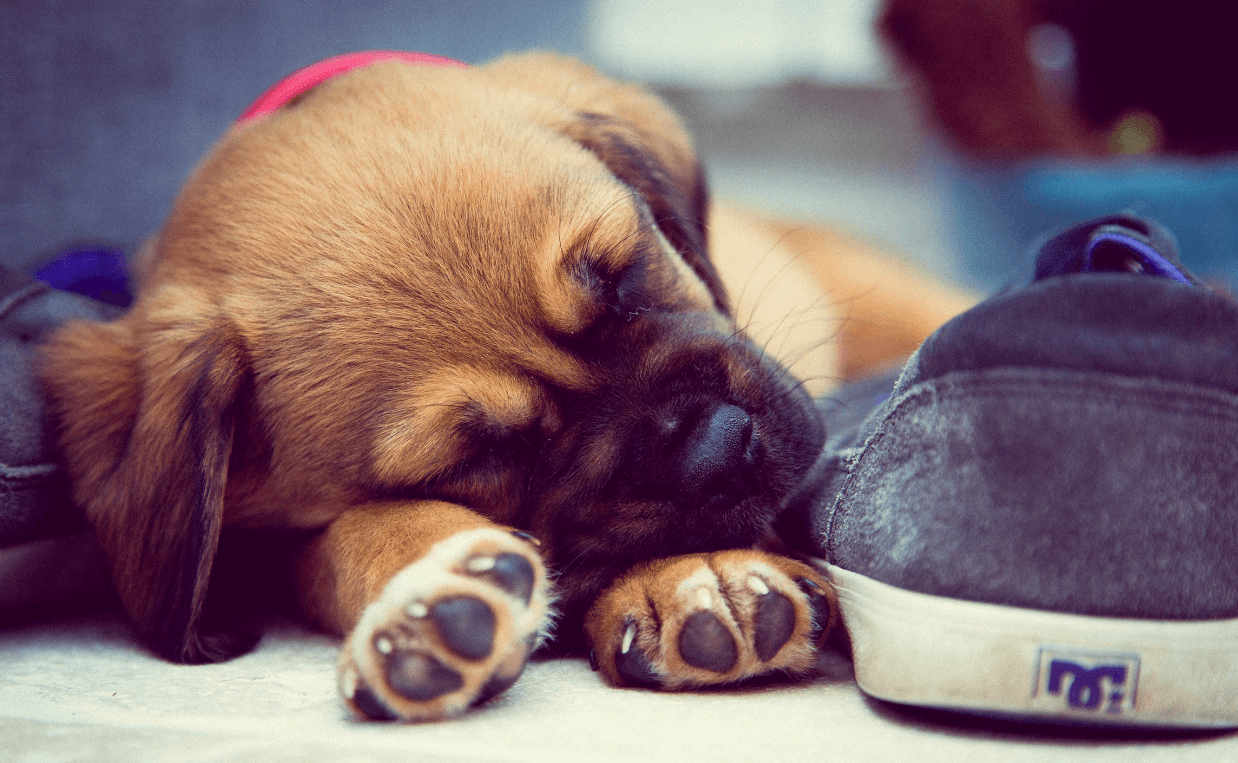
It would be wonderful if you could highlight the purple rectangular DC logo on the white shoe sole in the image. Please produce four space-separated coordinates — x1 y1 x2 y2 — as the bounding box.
1032 647 1139 716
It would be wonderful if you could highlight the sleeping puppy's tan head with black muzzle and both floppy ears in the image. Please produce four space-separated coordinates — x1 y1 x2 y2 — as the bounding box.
47 56 822 660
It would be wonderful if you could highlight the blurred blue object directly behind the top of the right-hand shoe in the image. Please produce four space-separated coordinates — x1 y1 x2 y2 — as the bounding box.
938 155 1238 291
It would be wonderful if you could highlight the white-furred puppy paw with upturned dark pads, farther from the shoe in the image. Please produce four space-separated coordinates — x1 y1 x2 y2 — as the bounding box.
338 528 550 721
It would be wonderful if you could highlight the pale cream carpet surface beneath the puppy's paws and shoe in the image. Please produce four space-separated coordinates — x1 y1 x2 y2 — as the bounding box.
0 612 1238 763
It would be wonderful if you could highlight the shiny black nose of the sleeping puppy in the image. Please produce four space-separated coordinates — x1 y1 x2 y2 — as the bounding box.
669 404 753 507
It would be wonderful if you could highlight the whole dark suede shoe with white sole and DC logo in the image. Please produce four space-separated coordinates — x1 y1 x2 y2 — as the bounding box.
781 216 1238 727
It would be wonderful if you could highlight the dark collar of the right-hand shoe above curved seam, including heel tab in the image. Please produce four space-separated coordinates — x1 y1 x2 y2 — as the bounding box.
899 216 1238 394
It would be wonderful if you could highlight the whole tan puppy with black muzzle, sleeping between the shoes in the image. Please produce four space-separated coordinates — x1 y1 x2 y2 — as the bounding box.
36 55 945 720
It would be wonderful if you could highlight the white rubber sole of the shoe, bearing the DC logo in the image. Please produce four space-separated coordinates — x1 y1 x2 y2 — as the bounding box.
817 561 1238 727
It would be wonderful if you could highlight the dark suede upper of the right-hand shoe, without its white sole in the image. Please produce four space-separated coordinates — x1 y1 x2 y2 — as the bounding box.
780 217 1238 619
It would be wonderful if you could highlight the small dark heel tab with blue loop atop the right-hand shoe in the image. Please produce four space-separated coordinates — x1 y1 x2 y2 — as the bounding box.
1032 214 1198 285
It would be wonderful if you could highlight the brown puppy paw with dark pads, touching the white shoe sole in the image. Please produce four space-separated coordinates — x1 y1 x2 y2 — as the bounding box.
586 550 838 689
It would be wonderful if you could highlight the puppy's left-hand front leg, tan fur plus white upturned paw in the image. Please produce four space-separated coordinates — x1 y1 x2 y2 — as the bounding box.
297 502 550 721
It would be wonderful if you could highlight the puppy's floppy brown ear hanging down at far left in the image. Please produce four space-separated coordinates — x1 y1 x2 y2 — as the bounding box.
42 303 255 663
